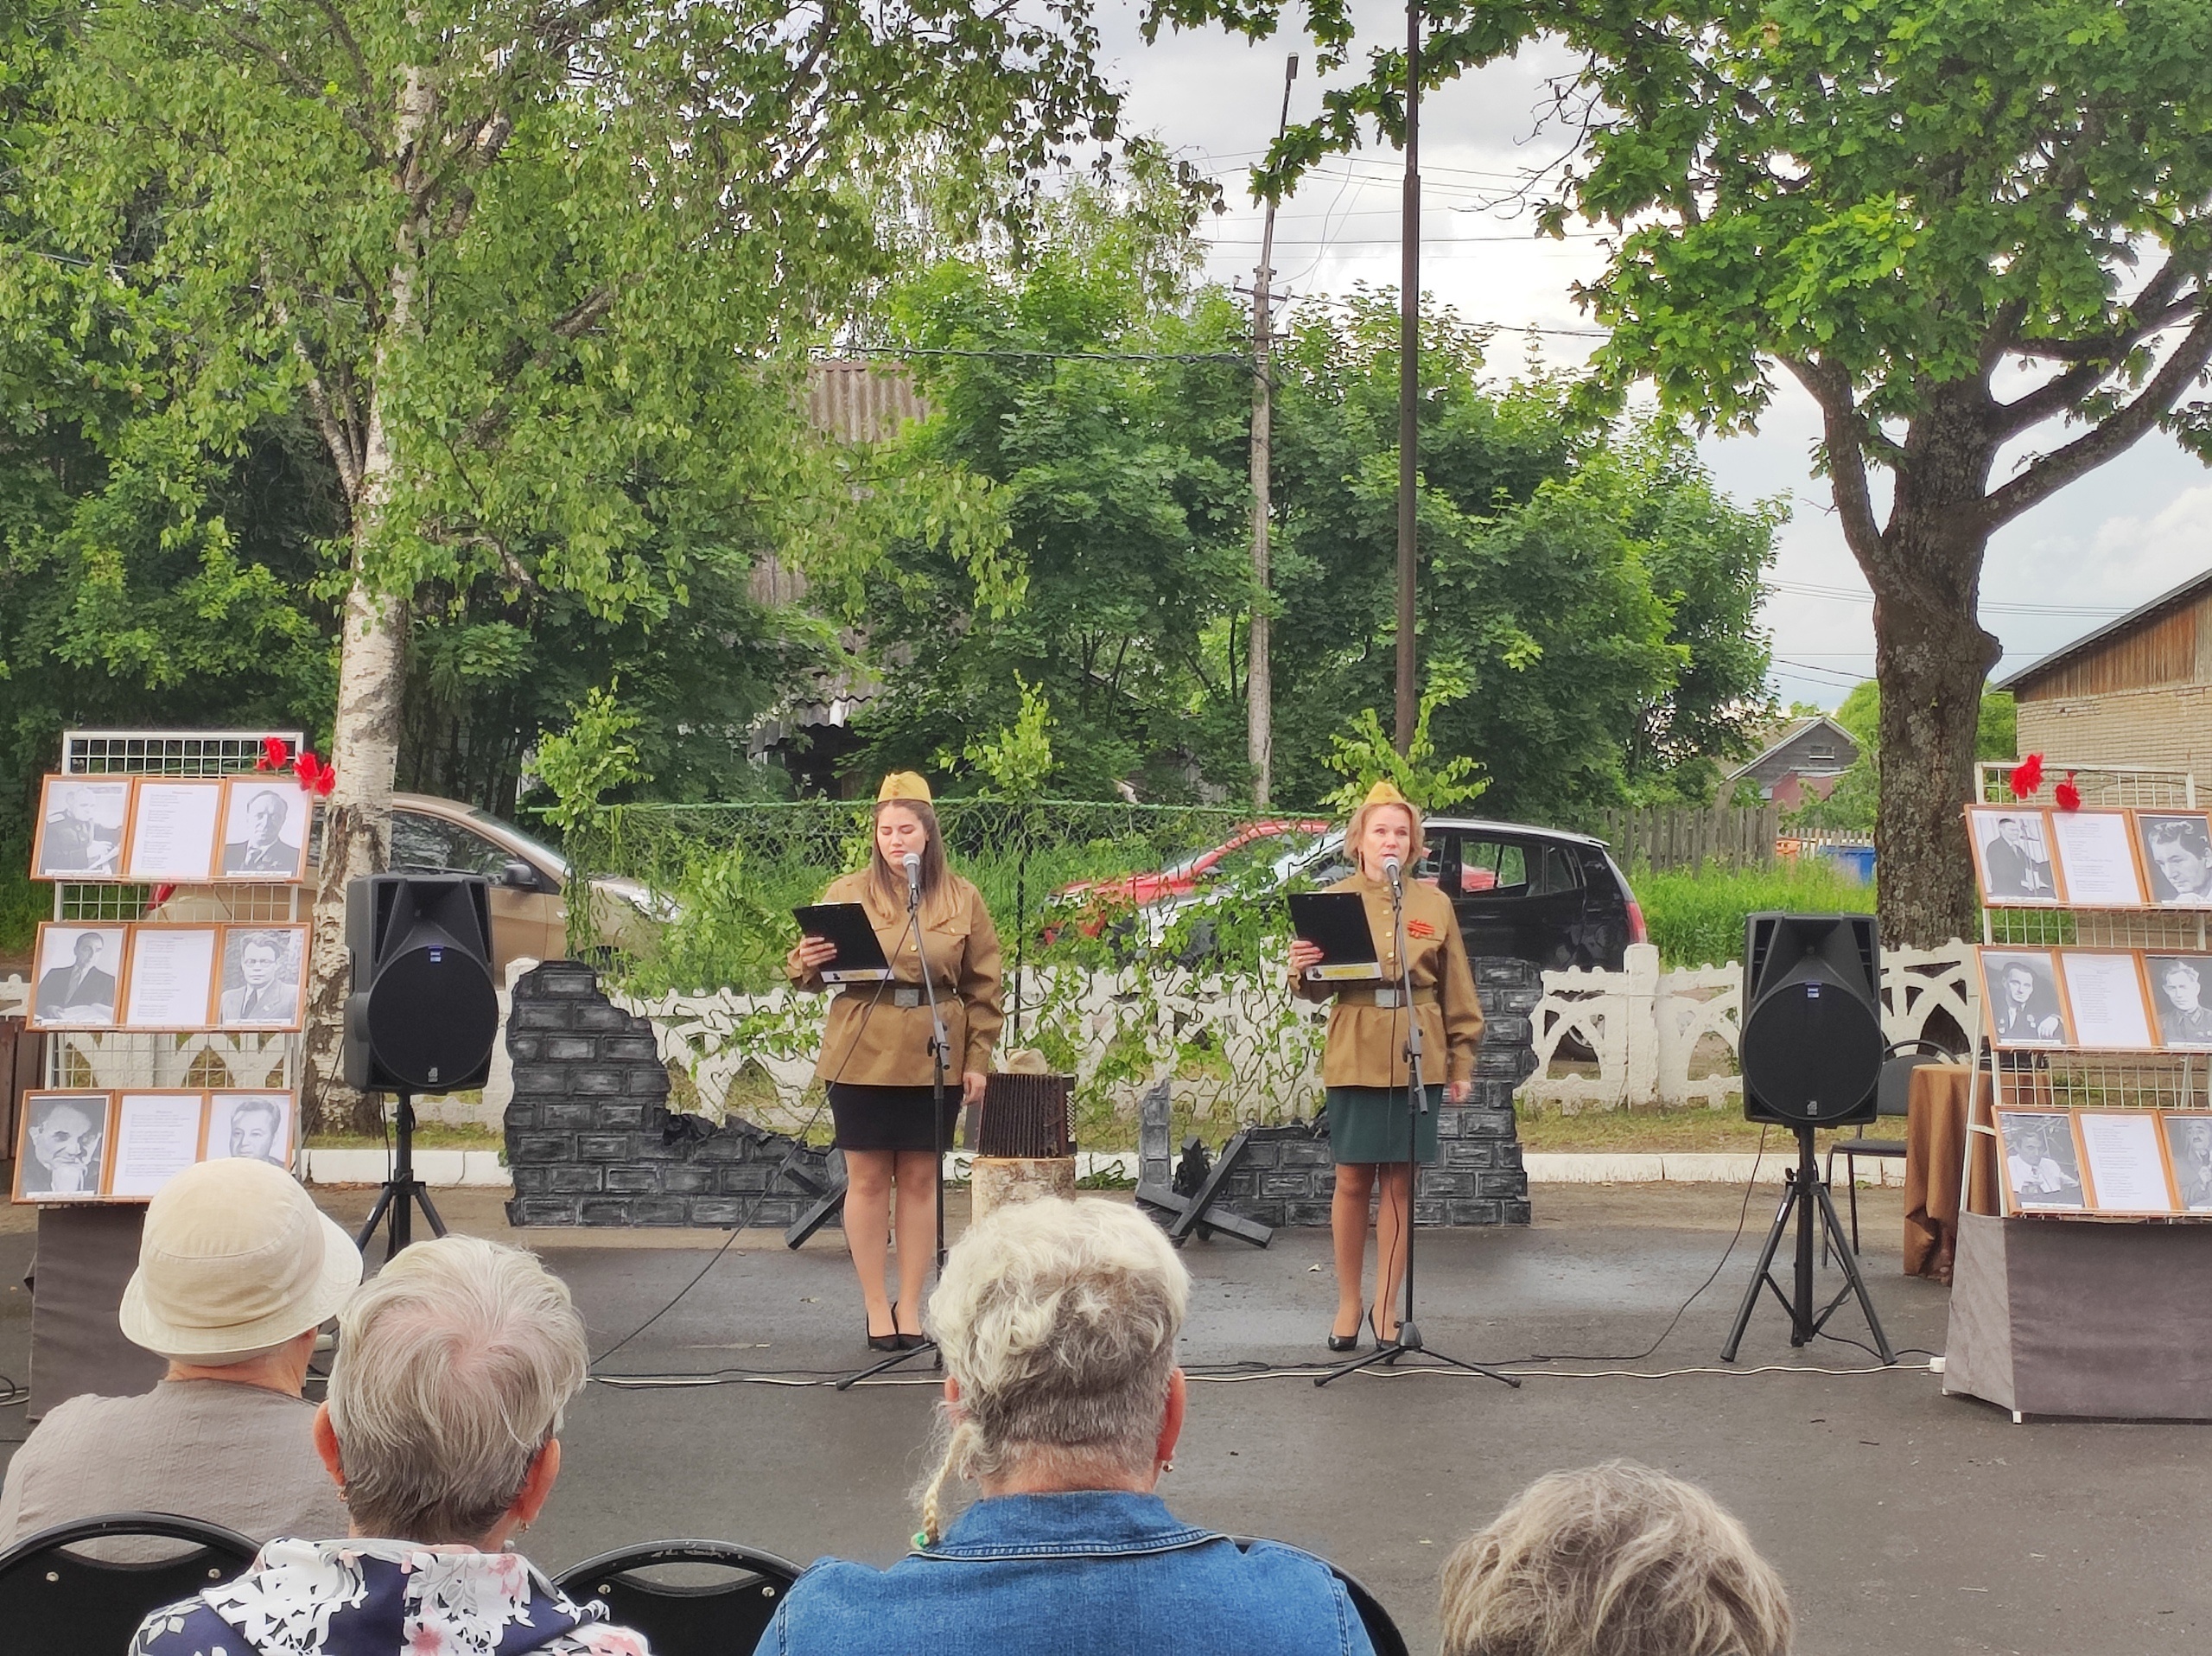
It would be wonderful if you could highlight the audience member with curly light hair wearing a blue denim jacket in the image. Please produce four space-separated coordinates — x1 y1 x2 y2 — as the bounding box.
759 1198 1371 1656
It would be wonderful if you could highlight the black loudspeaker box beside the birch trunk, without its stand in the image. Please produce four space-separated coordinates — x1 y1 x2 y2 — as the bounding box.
345 875 500 1093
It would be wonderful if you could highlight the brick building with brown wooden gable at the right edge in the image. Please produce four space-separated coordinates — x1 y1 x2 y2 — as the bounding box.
1995 569 2212 780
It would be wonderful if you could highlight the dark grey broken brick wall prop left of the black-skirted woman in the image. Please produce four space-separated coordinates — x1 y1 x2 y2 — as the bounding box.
506 961 834 1229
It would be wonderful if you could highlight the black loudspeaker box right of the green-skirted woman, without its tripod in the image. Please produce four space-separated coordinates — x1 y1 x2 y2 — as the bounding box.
1738 914 1887 1127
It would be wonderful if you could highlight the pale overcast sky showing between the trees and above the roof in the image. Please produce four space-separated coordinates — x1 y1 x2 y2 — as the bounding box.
1099 0 2212 706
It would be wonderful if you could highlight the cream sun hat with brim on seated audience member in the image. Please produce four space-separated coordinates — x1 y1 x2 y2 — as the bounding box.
118 1156 360 1368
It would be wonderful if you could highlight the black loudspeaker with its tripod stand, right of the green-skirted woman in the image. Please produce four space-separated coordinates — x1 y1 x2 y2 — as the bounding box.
1721 914 1896 1364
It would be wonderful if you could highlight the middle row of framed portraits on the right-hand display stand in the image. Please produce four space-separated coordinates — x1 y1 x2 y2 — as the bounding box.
1978 946 2212 1052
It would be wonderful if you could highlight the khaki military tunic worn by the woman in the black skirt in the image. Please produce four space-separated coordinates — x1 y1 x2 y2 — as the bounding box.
783 872 1007 1087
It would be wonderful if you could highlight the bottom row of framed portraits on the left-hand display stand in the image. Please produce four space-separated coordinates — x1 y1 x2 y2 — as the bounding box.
13 1087 299 1202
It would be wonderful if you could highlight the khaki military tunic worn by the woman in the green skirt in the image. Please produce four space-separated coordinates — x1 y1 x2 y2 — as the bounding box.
1292 875 1482 1087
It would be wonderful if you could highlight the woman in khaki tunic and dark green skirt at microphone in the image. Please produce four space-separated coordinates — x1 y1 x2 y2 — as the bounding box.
1289 781 1482 1351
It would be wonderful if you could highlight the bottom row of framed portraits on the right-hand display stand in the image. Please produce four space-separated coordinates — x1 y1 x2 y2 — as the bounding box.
1993 1105 2212 1220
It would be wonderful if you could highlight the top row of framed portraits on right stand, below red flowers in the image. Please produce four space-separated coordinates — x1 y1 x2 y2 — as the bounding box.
1967 804 2212 910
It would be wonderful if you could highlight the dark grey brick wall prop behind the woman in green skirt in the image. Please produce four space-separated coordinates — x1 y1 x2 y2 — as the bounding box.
1137 957 1544 1225
